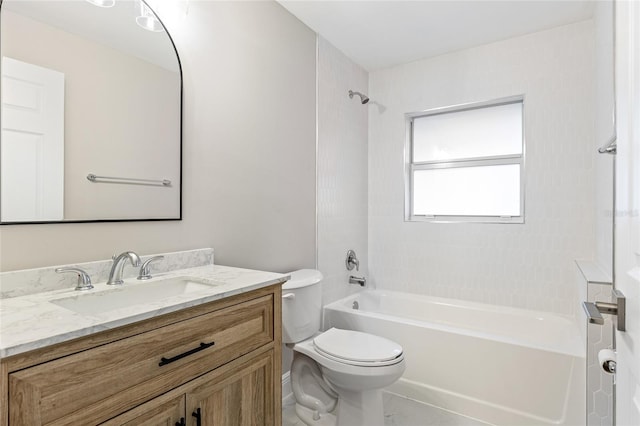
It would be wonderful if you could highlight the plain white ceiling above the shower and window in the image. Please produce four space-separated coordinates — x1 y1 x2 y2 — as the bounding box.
278 0 596 71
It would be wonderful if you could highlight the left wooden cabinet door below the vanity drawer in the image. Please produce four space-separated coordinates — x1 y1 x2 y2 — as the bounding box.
101 395 187 426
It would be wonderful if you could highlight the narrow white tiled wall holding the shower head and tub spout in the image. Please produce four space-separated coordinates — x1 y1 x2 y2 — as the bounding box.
318 37 371 303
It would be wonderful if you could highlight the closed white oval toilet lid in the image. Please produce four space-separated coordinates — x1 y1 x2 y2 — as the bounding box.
313 328 402 363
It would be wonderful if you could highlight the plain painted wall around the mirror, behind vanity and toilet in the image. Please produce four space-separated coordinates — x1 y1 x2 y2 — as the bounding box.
0 1 316 271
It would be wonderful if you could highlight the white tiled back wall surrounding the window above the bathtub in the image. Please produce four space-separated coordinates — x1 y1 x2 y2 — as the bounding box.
369 21 595 313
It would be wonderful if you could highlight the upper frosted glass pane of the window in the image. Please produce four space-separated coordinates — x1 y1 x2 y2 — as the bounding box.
413 102 522 162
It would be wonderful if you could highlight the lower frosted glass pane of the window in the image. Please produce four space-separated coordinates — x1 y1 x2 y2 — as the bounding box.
413 164 520 216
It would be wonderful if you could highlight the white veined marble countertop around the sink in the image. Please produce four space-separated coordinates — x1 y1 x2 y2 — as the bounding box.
0 265 289 358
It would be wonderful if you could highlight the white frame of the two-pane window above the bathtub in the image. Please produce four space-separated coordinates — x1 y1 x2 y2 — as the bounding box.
404 95 526 224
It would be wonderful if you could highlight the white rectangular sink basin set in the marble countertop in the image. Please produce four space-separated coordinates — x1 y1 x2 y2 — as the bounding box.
51 277 223 315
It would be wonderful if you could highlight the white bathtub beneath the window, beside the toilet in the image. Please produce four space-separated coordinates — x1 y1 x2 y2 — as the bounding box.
324 290 586 426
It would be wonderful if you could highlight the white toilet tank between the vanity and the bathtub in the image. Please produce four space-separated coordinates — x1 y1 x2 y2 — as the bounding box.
282 269 322 343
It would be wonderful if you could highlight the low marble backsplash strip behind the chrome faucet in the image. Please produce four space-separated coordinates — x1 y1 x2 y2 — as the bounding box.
0 248 213 299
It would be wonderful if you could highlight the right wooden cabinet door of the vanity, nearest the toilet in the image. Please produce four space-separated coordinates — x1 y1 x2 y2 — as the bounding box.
186 350 279 426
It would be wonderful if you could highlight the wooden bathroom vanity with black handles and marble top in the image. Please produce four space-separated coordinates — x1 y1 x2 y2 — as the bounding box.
0 258 288 426
